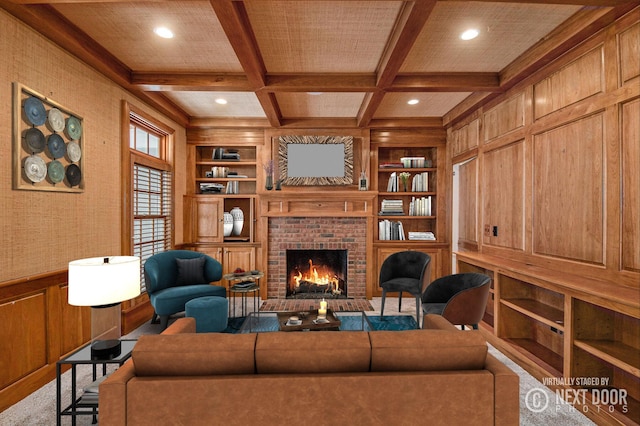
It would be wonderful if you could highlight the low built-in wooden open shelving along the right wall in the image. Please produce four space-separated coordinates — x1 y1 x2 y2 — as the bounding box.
456 252 640 424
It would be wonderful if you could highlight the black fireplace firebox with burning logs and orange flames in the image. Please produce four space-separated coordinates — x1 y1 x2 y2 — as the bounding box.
286 249 348 299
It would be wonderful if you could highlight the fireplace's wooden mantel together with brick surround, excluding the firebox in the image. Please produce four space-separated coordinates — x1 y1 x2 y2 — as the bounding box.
259 188 376 299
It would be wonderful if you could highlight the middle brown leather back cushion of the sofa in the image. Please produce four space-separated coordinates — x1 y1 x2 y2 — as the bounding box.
256 331 371 374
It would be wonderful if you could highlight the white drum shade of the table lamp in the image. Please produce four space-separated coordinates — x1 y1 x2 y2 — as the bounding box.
69 256 140 306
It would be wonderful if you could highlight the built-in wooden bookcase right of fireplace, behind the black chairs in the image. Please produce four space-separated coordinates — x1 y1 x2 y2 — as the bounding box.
371 128 451 296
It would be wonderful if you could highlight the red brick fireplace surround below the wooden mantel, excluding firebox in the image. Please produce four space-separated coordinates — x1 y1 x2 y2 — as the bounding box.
267 217 367 299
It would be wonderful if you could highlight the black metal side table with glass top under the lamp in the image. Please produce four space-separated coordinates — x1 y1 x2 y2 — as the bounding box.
56 340 137 426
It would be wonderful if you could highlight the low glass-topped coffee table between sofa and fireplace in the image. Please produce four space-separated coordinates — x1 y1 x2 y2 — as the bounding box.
239 310 373 333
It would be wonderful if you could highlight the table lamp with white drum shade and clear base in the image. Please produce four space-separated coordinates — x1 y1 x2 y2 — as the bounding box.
69 256 140 359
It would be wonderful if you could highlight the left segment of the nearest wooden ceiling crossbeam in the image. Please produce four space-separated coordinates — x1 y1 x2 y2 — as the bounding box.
131 72 253 92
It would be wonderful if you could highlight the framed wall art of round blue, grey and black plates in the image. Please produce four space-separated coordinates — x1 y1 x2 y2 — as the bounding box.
13 82 84 192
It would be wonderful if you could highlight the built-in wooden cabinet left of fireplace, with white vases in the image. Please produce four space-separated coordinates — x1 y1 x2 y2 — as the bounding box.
181 129 263 274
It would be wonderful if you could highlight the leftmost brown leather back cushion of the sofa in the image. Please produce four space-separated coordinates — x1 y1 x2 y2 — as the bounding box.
131 333 256 376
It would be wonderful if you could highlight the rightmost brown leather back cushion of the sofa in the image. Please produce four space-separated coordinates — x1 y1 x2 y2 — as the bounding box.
369 330 487 371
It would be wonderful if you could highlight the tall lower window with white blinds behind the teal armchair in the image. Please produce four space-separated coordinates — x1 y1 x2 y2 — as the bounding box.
132 163 173 291
